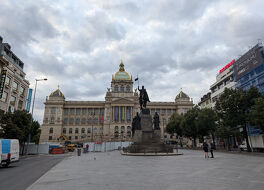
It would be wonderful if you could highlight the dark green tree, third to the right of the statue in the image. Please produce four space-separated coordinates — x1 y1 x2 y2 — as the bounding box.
196 108 216 140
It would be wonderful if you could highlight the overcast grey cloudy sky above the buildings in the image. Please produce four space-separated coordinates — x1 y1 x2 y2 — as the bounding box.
0 0 264 123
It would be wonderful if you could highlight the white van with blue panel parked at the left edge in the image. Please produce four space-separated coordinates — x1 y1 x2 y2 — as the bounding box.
0 139 19 167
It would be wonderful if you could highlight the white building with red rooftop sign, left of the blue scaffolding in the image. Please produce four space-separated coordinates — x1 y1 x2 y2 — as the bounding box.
210 60 235 108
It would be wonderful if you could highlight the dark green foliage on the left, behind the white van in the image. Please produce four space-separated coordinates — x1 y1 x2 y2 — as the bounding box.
0 110 40 143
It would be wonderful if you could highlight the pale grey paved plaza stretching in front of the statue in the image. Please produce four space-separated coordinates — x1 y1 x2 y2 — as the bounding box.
28 150 264 190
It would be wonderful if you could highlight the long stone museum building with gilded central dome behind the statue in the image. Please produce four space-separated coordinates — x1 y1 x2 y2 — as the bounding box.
40 62 194 143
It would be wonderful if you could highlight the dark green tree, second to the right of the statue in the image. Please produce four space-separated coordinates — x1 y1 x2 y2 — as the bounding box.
181 106 199 147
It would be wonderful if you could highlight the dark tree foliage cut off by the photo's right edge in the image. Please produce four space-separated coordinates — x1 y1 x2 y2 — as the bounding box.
248 97 264 131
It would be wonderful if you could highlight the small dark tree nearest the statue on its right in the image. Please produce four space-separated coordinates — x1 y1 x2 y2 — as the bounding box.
166 113 183 136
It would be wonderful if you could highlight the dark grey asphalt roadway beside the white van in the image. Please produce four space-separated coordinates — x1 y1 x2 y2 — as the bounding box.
0 155 67 190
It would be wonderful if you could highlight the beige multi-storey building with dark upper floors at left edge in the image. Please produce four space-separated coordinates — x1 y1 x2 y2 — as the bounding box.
0 38 29 114
